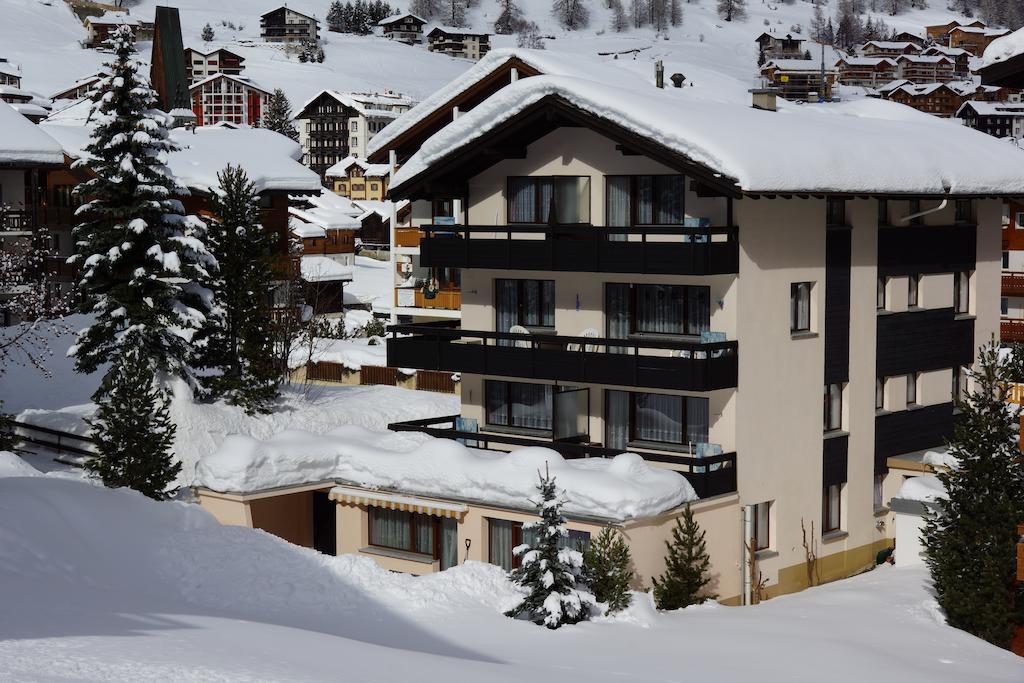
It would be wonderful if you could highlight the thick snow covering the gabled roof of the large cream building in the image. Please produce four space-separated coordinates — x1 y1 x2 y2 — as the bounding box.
391 76 1024 196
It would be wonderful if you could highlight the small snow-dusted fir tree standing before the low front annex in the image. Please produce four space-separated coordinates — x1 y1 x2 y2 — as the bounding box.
505 471 594 629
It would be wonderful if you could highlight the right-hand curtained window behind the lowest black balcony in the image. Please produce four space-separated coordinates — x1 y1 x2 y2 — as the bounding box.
604 389 710 449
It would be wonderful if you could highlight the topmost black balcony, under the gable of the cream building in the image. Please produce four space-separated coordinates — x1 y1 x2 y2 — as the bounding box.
420 225 739 275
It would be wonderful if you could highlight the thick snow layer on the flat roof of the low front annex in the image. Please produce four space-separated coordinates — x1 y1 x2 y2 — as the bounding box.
196 426 696 520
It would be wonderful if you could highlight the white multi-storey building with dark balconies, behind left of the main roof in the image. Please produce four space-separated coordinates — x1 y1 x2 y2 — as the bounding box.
295 90 416 183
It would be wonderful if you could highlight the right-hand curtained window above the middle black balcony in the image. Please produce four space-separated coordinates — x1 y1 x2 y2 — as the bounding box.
605 283 711 339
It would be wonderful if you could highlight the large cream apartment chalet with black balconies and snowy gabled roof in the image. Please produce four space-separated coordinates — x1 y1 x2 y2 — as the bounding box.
366 51 1007 597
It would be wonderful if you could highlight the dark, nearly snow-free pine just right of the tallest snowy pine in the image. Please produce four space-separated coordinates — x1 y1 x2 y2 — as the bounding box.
192 165 280 415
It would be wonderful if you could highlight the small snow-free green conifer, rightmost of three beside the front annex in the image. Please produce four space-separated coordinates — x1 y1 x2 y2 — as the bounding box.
653 505 715 609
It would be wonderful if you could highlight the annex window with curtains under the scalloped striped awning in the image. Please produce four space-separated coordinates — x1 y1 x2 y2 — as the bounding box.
368 506 459 569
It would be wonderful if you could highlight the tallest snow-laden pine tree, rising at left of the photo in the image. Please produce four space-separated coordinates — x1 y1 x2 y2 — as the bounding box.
69 27 217 395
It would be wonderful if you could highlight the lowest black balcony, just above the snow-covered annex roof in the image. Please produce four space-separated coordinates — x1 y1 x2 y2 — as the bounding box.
388 416 736 499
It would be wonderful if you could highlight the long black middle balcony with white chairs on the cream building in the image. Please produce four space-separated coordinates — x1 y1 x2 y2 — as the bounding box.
387 325 738 391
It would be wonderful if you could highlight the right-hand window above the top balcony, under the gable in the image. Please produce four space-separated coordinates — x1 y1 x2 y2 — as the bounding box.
605 175 686 226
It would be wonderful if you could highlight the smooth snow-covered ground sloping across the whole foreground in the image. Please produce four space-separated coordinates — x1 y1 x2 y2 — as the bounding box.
0 475 1024 683
